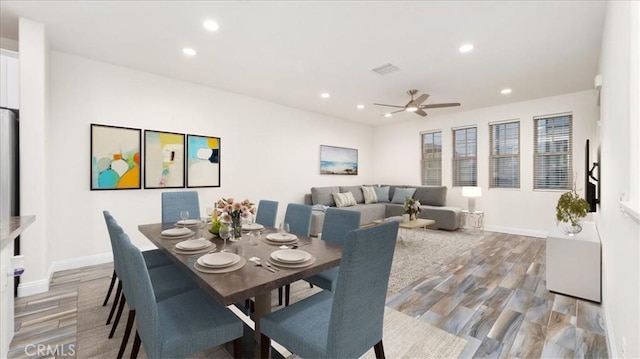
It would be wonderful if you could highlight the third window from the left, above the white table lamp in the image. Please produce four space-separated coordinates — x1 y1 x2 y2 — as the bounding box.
489 121 520 188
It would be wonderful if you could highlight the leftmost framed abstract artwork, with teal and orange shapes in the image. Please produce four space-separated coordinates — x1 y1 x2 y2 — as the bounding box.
90 123 142 191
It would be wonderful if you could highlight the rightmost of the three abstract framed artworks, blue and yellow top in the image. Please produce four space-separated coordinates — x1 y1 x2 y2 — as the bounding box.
187 135 220 187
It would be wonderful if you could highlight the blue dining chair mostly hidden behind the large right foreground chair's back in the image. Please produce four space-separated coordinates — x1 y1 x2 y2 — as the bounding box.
304 208 361 292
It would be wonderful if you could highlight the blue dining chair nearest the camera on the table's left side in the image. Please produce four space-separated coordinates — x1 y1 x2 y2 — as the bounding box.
120 233 243 358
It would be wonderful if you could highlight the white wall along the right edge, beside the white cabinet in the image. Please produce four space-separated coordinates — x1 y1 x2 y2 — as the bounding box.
596 1 640 358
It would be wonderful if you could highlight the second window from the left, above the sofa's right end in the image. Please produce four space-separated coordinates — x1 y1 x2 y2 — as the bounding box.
453 127 478 187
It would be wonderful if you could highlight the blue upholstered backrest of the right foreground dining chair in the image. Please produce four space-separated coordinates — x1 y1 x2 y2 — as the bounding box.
327 221 398 358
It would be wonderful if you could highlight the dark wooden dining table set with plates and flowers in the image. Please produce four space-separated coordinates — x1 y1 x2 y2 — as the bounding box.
138 223 342 354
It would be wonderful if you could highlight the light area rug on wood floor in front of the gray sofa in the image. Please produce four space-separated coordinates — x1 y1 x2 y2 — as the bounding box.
388 229 491 294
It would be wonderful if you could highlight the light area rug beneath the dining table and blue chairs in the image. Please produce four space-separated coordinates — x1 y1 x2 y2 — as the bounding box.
76 268 467 359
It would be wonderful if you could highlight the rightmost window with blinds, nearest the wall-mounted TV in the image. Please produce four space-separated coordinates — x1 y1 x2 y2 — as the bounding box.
533 114 573 189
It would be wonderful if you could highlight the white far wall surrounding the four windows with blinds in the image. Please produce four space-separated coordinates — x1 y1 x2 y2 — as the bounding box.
374 90 598 237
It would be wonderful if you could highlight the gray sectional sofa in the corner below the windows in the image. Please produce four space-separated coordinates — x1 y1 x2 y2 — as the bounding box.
305 185 462 236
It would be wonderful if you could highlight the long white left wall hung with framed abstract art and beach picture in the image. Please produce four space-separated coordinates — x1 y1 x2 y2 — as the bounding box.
43 52 373 267
